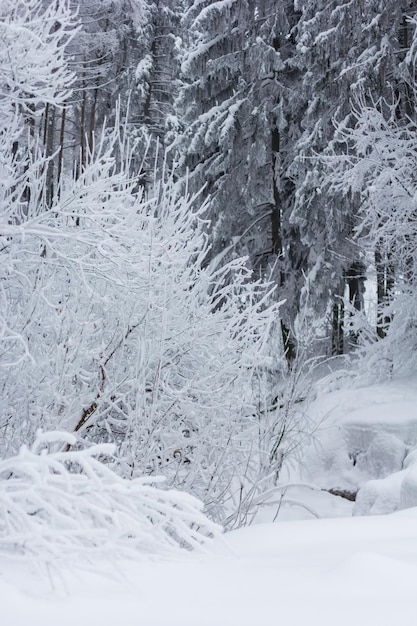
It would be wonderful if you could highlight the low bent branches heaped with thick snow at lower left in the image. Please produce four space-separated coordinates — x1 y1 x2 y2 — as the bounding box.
0 432 220 560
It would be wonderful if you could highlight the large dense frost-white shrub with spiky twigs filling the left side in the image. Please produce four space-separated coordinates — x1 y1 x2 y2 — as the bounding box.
0 0 296 524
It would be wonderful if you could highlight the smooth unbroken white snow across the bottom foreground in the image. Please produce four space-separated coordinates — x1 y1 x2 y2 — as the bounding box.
0 509 417 626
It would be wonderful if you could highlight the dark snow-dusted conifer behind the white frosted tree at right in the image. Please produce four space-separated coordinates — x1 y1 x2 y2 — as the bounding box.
291 0 415 352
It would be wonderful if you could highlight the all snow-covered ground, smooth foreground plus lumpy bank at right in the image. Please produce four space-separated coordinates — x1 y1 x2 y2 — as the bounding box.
0 372 417 626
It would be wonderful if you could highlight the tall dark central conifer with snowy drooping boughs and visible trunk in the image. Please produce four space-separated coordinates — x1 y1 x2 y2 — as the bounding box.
177 0 308 360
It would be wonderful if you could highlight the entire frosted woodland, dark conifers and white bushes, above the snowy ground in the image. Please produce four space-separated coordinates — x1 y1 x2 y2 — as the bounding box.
0 0 417 526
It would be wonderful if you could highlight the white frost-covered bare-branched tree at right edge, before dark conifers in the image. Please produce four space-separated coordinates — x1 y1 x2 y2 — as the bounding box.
323 98 417 375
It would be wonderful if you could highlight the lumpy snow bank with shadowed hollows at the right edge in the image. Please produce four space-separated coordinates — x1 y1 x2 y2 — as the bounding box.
290 380 417 516
